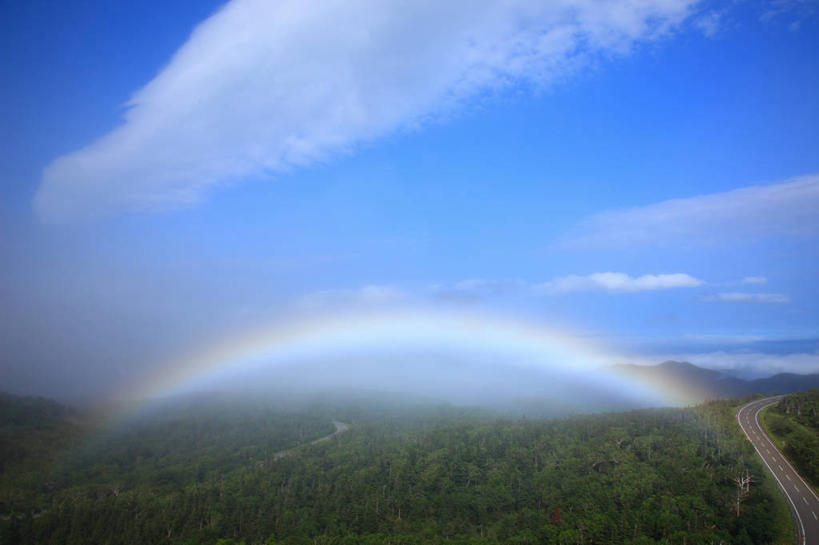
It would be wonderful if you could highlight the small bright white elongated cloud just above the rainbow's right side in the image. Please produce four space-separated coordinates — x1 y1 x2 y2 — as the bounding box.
533 272 705 295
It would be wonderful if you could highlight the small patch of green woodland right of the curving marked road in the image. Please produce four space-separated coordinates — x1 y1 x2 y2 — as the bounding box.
764 388 819 487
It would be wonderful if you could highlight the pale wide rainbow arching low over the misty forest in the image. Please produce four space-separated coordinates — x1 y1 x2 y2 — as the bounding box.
112 309 688 418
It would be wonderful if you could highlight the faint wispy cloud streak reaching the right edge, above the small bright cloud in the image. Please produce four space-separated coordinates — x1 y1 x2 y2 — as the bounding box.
560 175 819 249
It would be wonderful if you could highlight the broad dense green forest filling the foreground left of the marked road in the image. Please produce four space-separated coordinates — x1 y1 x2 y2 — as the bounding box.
0 396 791 545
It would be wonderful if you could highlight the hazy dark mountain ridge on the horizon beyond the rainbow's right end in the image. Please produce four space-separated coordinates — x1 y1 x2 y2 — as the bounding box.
612 360 819 401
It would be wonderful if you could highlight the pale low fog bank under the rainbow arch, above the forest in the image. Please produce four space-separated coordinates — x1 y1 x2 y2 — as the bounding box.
163 352 668 416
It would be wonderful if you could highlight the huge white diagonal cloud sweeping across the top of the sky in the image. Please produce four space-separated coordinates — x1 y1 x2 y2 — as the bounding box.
34 0 695 220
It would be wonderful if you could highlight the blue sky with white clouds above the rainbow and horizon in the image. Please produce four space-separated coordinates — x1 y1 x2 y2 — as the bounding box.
0 0 819 400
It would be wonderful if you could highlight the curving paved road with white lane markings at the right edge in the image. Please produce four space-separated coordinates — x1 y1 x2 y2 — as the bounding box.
737 396 819 545
